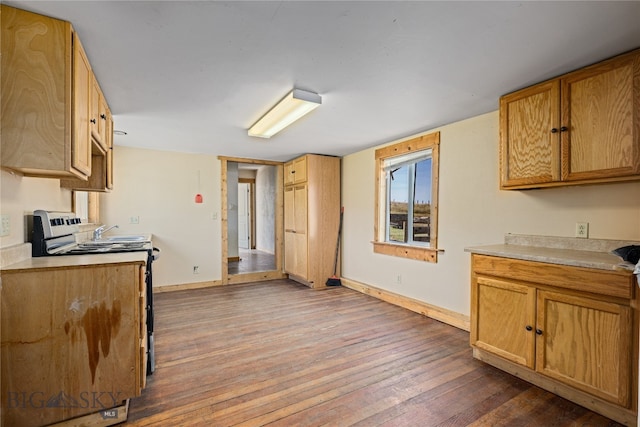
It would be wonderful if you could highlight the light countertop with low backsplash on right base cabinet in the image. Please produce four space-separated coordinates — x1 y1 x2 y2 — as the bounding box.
465 234 640 271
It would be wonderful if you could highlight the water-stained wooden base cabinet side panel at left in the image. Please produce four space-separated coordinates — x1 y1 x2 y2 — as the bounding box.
1 253 147 426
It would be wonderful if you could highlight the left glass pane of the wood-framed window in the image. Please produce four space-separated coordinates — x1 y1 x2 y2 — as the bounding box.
387 166 409 242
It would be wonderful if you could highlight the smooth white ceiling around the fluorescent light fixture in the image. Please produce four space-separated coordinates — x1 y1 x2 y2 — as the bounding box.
5 1 640 161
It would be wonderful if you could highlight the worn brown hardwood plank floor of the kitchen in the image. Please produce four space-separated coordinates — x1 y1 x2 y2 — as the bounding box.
126 280 619 427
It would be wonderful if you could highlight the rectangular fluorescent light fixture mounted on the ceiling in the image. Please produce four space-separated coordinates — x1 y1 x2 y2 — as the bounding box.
249 89 322 138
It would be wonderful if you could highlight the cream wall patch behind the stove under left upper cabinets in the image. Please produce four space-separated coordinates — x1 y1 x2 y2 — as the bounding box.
0 170 71 248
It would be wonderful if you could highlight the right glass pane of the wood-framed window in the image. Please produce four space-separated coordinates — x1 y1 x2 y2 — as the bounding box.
412 158 431 243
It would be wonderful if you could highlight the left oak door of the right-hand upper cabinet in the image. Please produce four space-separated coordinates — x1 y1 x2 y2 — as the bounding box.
500 80 560 188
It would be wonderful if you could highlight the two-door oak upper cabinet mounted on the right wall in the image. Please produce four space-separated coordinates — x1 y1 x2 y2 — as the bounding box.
500 50 640 190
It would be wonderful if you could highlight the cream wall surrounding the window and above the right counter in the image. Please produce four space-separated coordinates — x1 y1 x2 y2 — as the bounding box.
342 111 640 315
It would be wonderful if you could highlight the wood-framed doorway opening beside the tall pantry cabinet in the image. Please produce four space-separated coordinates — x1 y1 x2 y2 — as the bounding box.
219 157 285 284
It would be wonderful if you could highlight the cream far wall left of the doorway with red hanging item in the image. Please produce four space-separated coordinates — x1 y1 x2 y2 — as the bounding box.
100 146 221 286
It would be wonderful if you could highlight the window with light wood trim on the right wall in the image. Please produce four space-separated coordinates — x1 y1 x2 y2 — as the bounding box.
373 132 440 262
